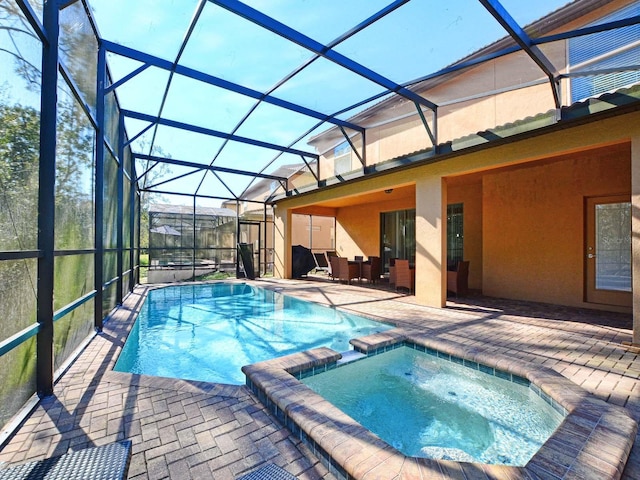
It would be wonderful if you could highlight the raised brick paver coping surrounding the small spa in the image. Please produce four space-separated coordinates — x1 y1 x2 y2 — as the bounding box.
242 328 638 480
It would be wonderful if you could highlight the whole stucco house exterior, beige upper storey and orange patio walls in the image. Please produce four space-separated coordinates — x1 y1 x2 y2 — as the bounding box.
278 0 640 332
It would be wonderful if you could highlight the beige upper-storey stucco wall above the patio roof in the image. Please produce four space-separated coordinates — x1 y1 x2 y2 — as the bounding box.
310 0 632 179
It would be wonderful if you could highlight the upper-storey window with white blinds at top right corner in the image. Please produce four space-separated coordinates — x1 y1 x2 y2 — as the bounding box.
569 2 640 102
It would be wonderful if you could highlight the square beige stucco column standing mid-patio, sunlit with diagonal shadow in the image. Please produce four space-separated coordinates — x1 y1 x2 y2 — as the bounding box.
415 176 447 308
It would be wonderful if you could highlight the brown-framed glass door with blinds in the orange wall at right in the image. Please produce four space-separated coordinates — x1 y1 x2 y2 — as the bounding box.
585 195 632 306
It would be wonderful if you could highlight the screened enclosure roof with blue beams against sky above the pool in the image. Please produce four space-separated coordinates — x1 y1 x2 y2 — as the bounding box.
86 0 640 207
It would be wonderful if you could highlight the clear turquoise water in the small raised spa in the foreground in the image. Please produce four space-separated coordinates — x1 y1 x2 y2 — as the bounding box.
302 346 563 466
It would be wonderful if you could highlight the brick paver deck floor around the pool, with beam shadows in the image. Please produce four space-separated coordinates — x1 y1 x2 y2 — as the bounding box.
0 279 640 480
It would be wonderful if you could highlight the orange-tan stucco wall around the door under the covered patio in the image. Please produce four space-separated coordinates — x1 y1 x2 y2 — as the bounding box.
482 144 631 306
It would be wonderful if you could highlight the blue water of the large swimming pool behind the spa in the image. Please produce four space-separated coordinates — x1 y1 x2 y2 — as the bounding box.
114 283 392 385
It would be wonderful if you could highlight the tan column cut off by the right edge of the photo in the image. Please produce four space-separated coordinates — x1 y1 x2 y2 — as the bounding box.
631 135 640 345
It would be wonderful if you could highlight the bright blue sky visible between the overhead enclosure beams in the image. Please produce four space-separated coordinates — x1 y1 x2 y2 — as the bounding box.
0 0 568 201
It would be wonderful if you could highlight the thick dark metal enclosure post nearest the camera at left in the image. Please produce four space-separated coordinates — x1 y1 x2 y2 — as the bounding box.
36 0 59 398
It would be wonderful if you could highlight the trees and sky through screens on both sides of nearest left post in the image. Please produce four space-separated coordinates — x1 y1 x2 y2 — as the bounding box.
0 1 95 425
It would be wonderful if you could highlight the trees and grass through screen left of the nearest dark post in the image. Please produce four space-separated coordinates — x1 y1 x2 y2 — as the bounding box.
0 95 40 424
